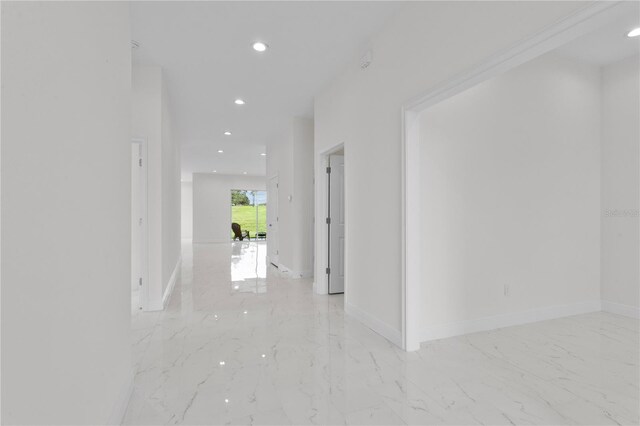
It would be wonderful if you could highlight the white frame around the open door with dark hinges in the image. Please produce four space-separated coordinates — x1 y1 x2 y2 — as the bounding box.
313 142 342 296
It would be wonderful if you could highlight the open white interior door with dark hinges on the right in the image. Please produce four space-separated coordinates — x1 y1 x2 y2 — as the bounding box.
327 155 344 294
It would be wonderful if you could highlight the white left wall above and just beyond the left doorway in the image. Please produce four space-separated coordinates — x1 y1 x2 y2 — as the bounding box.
131 66 181 310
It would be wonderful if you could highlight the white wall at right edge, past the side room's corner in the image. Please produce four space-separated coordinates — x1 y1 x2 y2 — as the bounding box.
602 56 640 315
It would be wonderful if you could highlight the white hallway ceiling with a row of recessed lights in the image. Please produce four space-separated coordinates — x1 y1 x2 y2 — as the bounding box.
131 1 401 181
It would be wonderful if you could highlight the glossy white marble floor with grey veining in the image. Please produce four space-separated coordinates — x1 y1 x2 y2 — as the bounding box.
125 242 639 425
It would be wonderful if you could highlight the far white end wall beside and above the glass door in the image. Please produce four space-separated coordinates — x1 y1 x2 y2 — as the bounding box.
193 173 269 243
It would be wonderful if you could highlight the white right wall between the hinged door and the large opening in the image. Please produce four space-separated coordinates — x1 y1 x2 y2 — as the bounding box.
315 2 586 339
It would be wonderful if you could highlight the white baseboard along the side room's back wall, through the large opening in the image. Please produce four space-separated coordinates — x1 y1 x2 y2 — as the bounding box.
419 300 601 342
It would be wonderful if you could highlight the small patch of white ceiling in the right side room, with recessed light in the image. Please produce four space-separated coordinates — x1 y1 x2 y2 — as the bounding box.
558 2 640 66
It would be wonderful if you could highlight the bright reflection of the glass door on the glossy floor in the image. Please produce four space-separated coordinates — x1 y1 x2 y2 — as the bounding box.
231 241 267 293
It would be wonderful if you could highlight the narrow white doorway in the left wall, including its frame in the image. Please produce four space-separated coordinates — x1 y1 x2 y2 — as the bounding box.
131 139 148 313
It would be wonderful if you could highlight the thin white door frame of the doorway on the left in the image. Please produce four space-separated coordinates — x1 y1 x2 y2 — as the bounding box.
131 138 151 311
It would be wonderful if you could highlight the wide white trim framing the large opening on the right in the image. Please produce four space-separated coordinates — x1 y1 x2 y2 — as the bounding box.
400 1 625 351
